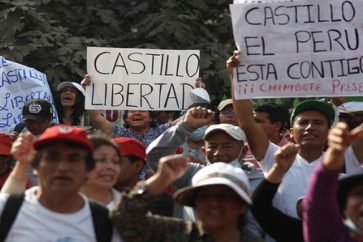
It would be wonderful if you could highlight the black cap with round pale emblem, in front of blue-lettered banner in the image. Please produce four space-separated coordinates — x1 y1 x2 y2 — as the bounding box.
22 99 53 122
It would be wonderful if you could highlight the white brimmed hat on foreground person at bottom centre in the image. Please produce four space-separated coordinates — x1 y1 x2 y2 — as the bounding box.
174 162 252 207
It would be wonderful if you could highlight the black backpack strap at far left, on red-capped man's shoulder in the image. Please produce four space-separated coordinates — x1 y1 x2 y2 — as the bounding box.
0 193 24 242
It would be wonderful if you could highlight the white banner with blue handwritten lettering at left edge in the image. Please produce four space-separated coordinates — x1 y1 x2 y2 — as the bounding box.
0 56 58 133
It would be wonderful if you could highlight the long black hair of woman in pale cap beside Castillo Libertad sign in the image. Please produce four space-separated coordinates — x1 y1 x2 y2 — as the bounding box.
55 88 85 125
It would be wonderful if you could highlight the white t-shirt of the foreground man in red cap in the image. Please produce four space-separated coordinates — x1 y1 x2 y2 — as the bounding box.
0 187 122 242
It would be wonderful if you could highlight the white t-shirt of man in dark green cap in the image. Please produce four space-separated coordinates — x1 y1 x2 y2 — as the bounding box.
260 142 360 218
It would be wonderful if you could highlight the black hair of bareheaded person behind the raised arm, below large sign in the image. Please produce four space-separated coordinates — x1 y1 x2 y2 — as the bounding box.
254 102 289 132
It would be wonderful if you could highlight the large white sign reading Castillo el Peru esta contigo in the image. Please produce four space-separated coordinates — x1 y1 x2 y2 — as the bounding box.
230 0 363 99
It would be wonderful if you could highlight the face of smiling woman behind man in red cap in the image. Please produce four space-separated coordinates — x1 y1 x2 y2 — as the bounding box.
87 145 121 189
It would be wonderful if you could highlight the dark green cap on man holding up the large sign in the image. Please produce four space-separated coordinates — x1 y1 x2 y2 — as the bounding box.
290 100 335 127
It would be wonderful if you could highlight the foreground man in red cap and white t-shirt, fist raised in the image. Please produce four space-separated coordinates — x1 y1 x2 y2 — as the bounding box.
0 125 121 242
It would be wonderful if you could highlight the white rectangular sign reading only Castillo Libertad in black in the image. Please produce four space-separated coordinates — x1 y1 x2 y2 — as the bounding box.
85 47 200 110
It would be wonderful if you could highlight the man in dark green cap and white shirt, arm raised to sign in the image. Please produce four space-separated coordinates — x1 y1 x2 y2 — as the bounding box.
227 52 363 217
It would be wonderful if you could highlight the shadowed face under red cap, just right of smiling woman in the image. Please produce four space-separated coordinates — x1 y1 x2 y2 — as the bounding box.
117 156 144 186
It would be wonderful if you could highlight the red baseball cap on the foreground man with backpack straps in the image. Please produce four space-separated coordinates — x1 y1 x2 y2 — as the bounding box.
34 125 93 151
